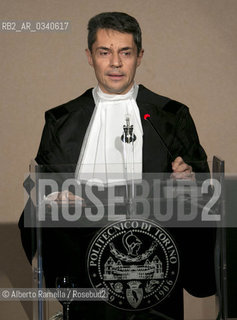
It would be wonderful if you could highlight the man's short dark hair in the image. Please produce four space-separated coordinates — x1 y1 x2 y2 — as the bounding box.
88 12 142 54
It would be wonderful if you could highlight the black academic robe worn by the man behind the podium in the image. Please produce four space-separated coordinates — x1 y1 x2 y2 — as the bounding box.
19 85 215 320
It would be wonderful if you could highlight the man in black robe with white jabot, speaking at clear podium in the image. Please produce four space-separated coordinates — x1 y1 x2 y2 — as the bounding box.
19 12 215 320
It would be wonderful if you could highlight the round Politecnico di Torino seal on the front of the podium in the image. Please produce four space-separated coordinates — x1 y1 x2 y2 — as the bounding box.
87 219 179 311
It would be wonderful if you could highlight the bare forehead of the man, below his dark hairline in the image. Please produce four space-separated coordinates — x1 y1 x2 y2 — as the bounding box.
94 29 135 47
